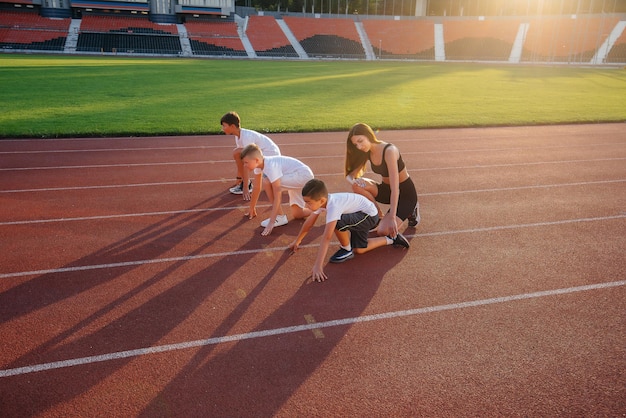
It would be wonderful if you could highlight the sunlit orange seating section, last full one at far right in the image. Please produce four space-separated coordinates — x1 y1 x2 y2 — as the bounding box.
522 17 618 63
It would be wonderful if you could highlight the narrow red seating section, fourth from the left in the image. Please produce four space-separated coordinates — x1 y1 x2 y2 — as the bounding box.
246 16 298 58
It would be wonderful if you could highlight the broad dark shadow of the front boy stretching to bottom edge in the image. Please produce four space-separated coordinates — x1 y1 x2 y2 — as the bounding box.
141 250 407 417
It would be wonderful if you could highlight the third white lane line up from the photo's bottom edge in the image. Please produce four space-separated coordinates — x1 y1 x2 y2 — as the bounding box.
0 180 626 226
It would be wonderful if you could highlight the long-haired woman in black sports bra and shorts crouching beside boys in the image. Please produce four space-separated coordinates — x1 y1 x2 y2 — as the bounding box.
345 123 420 237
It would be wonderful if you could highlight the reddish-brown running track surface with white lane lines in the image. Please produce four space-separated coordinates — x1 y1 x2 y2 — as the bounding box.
0 124 626 417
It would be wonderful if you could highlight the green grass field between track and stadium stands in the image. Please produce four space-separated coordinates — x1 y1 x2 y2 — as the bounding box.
0 55 626 138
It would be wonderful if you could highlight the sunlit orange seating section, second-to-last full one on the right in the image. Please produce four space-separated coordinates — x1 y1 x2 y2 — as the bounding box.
443 18 520 61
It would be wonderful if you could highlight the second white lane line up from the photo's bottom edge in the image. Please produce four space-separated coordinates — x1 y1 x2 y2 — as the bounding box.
0 214 626 279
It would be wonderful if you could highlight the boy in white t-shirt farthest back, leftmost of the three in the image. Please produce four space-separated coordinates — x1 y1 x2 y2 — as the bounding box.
220 112 280 200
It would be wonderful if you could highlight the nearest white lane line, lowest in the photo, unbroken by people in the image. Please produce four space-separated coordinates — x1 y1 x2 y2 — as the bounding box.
0 280 626 378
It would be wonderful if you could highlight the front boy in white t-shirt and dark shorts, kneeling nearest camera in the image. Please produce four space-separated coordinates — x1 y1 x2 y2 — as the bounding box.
289 179 410 282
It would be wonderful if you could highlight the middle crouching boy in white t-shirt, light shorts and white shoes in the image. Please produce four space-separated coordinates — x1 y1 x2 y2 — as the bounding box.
241 144 313 236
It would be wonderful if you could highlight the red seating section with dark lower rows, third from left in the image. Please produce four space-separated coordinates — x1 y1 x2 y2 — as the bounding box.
185 20 248 57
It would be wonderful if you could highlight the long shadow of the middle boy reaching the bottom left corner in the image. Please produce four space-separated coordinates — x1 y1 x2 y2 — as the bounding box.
0 212 278 416
